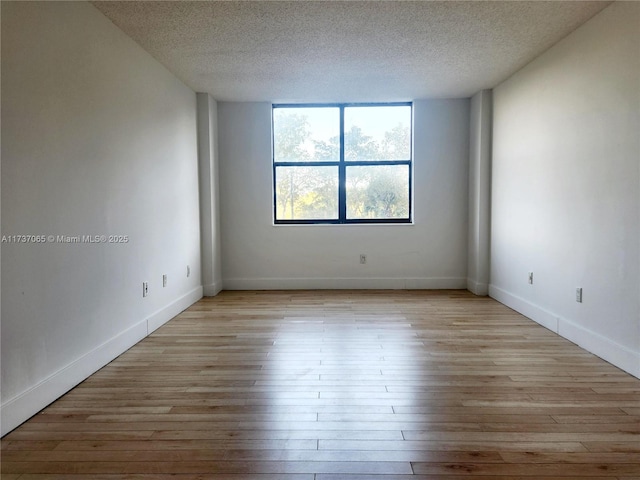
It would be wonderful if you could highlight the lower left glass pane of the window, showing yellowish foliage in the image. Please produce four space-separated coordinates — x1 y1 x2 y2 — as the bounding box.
276 166 338 220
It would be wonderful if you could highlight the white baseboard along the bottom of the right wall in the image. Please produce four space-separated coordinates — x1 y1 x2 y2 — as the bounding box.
489 285 640 378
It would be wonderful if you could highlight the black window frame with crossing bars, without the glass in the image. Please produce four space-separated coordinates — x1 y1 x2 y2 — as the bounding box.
271 102 413 225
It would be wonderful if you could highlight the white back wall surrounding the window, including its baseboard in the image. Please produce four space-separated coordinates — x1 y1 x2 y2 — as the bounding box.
218 99 469 289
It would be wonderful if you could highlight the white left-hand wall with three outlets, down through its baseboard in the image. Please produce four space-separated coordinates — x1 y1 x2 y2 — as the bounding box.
2 2 202 433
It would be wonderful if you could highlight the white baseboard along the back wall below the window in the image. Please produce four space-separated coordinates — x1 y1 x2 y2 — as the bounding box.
224 277 467 290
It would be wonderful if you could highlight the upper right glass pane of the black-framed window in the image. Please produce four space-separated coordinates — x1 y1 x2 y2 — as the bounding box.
344 105 411 161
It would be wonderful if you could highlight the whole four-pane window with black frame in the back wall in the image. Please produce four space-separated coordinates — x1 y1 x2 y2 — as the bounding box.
273 103 412 224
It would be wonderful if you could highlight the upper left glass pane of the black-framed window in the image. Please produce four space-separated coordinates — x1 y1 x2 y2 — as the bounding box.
273 107 340 162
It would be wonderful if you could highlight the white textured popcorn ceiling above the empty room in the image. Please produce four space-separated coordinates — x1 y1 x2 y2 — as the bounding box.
92 0 610 102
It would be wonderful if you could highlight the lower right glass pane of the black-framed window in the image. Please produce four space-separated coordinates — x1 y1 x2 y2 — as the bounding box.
346 165 409 220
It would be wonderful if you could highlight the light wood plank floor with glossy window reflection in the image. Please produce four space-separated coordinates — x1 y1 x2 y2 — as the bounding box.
2 291 640 480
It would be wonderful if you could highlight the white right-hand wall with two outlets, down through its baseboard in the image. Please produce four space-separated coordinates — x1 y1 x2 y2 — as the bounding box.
490 2 640 376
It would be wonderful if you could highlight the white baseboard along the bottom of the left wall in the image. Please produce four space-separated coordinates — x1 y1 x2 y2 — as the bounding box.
0 287 202 436
